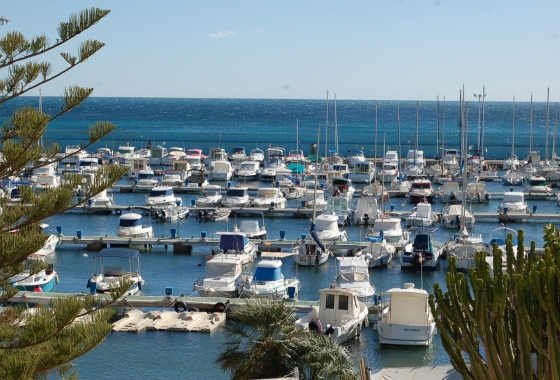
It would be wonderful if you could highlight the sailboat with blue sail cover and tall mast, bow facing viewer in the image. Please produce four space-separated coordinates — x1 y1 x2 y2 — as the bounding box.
294 126 330 266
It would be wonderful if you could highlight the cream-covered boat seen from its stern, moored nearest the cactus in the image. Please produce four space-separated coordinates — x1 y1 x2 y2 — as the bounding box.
375 283 437 346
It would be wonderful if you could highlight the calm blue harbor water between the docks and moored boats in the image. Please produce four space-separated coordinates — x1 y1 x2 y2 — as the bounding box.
42 176 558 379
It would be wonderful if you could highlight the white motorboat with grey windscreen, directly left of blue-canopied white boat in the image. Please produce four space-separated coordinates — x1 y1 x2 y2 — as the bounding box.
193 255 252 298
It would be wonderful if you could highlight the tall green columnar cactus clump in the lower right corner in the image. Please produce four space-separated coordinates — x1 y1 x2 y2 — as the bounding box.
429 225 560 380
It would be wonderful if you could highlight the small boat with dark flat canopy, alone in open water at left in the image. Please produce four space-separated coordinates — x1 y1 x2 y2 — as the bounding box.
87 248 144 296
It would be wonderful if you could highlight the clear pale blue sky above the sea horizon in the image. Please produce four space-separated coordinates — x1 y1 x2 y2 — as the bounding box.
0 0 560 101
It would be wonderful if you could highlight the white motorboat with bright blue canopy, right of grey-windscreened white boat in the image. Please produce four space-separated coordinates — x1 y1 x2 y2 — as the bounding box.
241 260 300 299
